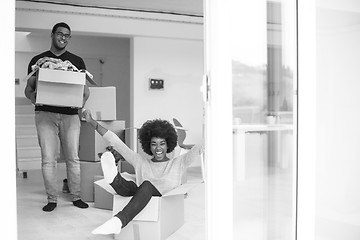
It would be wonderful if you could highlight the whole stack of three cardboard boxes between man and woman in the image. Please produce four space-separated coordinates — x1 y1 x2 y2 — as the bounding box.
79 87 125 202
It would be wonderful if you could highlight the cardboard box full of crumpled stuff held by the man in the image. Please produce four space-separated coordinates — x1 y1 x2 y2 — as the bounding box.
36 68 86 108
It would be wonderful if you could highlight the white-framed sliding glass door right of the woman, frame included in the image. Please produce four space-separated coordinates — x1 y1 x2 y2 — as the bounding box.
205 0 297 240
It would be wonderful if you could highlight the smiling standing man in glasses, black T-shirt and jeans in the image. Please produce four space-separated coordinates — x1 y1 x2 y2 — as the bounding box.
24 22 89 212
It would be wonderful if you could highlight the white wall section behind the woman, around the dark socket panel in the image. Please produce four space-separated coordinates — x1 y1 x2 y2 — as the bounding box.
132 37 203 143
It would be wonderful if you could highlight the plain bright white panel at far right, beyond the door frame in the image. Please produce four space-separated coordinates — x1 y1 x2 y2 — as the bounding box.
316 5 360 240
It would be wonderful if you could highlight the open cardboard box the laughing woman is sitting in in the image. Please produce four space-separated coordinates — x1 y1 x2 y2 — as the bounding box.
96 173 194 240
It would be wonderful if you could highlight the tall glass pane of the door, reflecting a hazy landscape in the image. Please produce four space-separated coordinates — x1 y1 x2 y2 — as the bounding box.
230 0 297 240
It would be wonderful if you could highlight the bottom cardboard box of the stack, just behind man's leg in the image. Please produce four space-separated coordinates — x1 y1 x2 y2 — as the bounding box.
80 161 103 202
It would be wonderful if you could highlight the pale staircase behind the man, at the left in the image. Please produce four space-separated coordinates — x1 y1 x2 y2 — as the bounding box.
15 97 41 172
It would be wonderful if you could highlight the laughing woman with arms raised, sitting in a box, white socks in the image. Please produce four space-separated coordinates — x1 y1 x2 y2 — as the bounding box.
83 110 202 234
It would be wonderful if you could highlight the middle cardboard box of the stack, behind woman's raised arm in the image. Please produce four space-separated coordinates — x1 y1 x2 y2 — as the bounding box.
79 120 125 162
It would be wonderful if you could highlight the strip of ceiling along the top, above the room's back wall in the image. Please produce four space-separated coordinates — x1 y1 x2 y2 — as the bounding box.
17 0 203 16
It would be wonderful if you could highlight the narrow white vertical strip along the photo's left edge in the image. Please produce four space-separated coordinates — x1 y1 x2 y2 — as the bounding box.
0 1 17 240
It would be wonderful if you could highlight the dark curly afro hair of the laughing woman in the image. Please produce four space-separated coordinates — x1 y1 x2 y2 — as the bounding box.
139 119 177 155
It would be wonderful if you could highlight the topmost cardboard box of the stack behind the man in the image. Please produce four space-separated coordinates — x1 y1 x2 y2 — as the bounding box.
84 87 116 121
